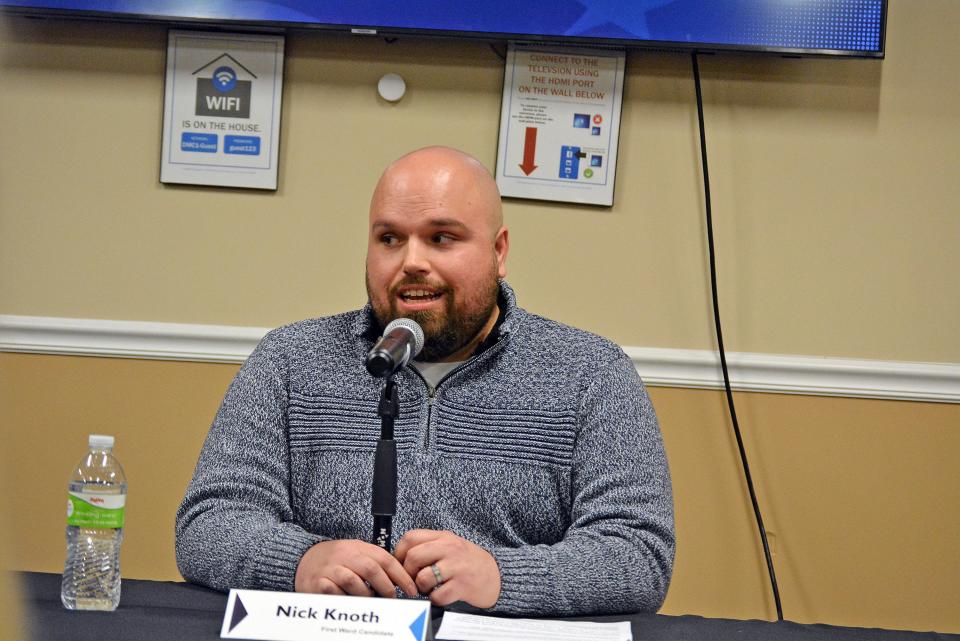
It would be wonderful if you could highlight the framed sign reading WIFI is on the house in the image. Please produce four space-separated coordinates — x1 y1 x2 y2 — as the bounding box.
160 30 284 189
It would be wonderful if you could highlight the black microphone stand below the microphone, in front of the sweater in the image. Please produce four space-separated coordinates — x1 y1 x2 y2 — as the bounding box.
370 374 400 552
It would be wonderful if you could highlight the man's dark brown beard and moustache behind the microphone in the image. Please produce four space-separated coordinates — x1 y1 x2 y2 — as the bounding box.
367 277 500 362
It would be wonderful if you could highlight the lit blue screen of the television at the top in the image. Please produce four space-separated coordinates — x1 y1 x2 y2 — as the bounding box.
0 0 887 58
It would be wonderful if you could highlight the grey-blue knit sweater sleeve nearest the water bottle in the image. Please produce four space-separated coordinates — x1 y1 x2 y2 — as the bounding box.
176 333 324 591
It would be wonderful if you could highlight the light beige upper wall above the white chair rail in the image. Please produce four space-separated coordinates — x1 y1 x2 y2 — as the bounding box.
0 0 960 362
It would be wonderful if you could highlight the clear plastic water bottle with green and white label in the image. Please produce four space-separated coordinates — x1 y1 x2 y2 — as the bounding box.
60 434 127 610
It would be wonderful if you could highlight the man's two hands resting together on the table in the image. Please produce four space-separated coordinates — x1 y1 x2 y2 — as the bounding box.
294 530 500 608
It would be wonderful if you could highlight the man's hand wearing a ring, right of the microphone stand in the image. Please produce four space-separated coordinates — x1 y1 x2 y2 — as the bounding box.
394 530 500 608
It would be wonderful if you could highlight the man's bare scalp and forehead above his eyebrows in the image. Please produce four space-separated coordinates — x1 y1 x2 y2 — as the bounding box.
370 146 503 237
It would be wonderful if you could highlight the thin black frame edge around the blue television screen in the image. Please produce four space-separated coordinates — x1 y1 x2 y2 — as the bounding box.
0 0 889 60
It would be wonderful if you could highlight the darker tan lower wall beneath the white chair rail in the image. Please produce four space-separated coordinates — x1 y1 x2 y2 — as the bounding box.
0 354 960 632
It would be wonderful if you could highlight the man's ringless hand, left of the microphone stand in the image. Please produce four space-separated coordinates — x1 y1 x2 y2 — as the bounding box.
294 540 417 597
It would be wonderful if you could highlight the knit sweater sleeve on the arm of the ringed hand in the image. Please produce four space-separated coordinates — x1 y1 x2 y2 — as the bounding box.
490 351 675 616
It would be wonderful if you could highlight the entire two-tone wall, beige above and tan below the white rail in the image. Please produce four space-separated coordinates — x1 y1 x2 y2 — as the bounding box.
0 0 960 632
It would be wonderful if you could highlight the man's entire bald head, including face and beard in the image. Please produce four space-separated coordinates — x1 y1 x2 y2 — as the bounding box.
367 147 510 361
